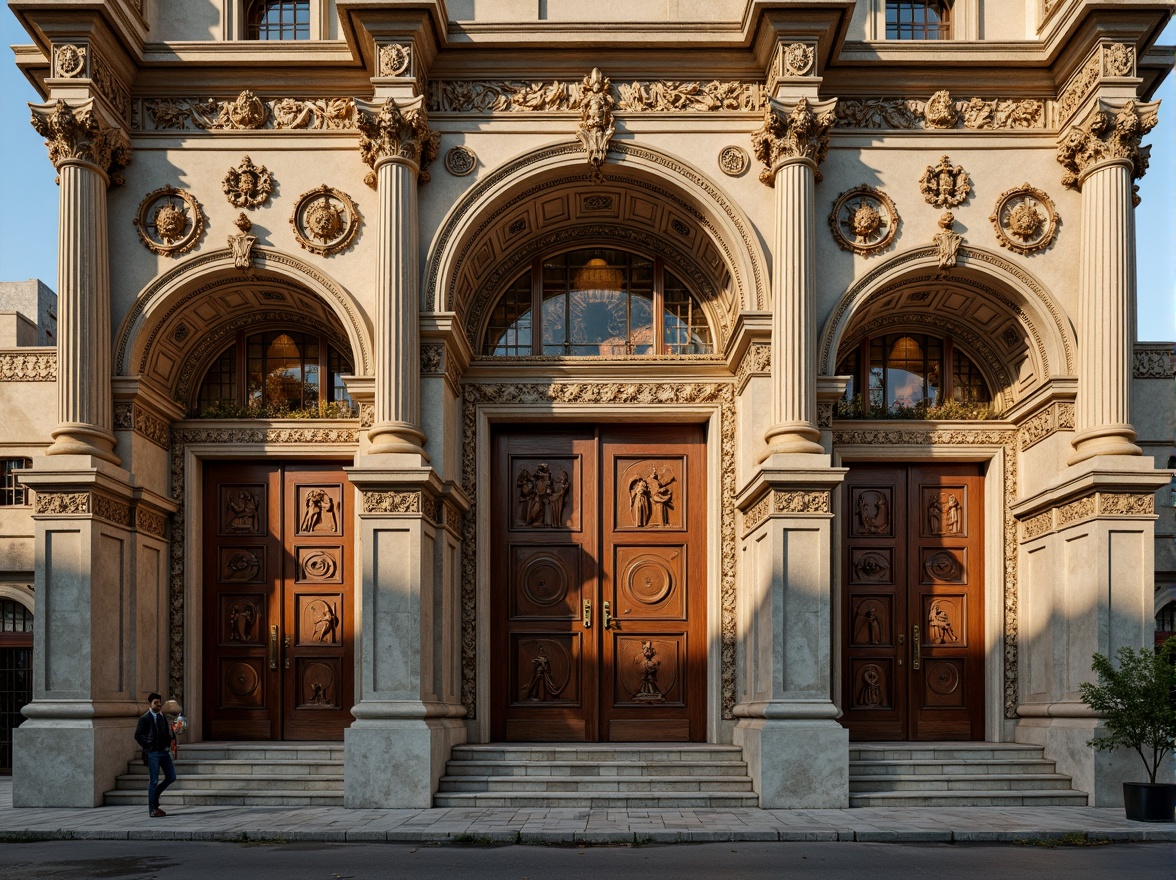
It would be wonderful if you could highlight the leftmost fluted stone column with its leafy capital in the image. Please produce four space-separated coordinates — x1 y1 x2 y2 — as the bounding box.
29 100 129 465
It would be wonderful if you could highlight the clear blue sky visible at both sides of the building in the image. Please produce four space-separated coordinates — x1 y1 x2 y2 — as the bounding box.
0 16 1176 341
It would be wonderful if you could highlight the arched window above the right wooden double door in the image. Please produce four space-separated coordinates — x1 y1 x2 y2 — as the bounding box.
837 333 993 412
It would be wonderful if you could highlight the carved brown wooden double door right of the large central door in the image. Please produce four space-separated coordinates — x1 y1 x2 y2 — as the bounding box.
841 465 984 741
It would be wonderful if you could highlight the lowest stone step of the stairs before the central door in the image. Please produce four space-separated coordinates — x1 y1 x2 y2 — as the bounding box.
433 792 760 809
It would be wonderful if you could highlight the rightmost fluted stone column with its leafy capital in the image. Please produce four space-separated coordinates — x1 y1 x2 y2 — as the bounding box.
1058 101 1158 465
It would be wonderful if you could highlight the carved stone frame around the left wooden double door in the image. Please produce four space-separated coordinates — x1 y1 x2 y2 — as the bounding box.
171 419 363 742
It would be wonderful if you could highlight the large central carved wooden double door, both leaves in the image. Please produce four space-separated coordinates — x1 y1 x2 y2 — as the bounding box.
490 425 707 742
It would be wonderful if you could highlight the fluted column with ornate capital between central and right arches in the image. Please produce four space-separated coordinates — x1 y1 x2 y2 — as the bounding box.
751 98 836 461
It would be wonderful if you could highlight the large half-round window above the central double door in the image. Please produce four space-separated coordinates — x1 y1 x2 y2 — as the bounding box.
483 248 711 358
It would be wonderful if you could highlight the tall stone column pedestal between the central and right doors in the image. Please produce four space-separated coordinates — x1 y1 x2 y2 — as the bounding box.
734 468 849 809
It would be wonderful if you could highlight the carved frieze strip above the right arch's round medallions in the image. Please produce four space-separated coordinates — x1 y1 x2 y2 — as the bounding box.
836 89 1045 131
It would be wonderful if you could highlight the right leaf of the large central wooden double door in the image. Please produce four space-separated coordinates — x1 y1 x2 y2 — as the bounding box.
601 425 707 742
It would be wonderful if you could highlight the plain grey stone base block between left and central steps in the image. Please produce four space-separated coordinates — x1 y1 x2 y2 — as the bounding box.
343 718 466 809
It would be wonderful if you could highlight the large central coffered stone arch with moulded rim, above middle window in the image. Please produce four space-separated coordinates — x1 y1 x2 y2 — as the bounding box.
421 141 768 351
